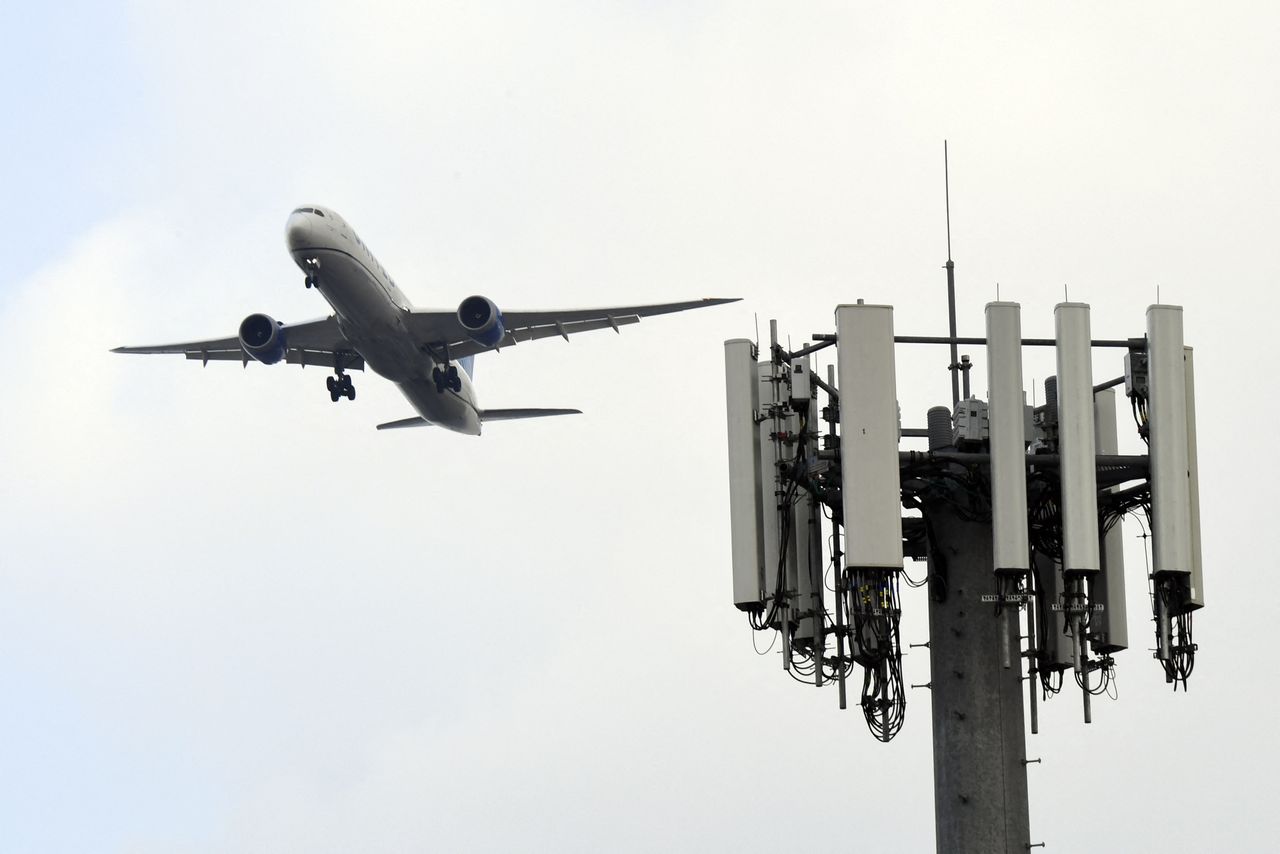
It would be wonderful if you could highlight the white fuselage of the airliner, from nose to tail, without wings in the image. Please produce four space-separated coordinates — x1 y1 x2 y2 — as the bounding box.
285 206 480 435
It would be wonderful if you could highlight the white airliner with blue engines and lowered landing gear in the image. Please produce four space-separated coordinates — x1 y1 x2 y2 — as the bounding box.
111 205 737 435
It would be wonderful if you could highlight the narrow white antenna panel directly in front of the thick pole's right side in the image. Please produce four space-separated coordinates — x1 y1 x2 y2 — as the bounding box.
987 302 1030 574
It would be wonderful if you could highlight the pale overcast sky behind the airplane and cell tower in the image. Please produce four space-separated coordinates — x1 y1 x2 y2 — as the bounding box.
0 0 1280 854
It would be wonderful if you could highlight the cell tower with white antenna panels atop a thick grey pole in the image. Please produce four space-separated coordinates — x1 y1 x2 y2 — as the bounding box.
724 153 1204 854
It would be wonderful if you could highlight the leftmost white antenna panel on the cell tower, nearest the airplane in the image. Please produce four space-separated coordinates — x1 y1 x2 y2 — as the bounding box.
724 338 764 611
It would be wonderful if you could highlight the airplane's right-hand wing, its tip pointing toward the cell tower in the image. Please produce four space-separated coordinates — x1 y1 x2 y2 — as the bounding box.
408 298 737 359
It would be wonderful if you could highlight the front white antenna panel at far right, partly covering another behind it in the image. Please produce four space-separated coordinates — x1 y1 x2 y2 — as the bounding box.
1147 305 1193 575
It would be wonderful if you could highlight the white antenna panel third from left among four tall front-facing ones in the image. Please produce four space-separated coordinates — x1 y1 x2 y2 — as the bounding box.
1053 302 1101 575
